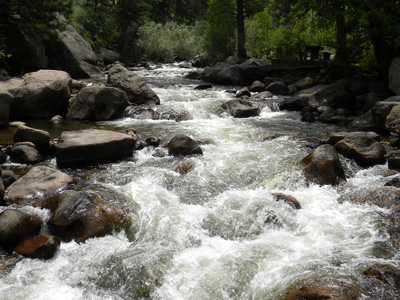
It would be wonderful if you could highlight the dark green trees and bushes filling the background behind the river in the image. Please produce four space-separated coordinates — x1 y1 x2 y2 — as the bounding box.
0 0 400 74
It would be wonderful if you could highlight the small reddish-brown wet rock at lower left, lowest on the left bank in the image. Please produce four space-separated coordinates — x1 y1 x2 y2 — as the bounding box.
14 234 61 259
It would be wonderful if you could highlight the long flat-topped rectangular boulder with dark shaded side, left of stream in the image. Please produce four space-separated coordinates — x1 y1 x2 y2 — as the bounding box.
56 129 136 168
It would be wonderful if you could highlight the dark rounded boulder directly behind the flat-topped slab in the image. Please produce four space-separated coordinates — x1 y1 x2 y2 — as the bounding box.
67 86 129 121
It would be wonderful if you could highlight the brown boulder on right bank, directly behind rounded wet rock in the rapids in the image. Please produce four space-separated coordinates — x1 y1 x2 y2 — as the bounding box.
335 134 386 167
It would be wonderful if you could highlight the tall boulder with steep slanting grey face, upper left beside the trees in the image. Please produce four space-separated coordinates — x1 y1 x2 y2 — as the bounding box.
46 25 101 78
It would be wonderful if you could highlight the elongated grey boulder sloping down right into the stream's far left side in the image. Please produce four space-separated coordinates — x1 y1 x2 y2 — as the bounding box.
107 64 160 104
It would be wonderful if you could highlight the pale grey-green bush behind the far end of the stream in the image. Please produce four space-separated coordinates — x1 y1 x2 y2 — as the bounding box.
136 22 202 62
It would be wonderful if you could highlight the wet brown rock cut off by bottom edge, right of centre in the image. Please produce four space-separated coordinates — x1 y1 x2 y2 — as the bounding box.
280 276 361 300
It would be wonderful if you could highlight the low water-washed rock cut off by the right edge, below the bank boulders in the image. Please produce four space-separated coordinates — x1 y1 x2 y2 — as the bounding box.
362 187 400 213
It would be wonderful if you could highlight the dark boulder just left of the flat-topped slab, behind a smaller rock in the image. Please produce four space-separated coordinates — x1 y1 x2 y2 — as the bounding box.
14 125 50 154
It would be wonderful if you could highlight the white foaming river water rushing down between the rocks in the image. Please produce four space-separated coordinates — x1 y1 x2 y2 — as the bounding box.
0 62 399 300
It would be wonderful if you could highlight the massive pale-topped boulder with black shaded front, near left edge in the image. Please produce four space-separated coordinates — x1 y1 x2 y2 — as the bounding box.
7 70 71 119
